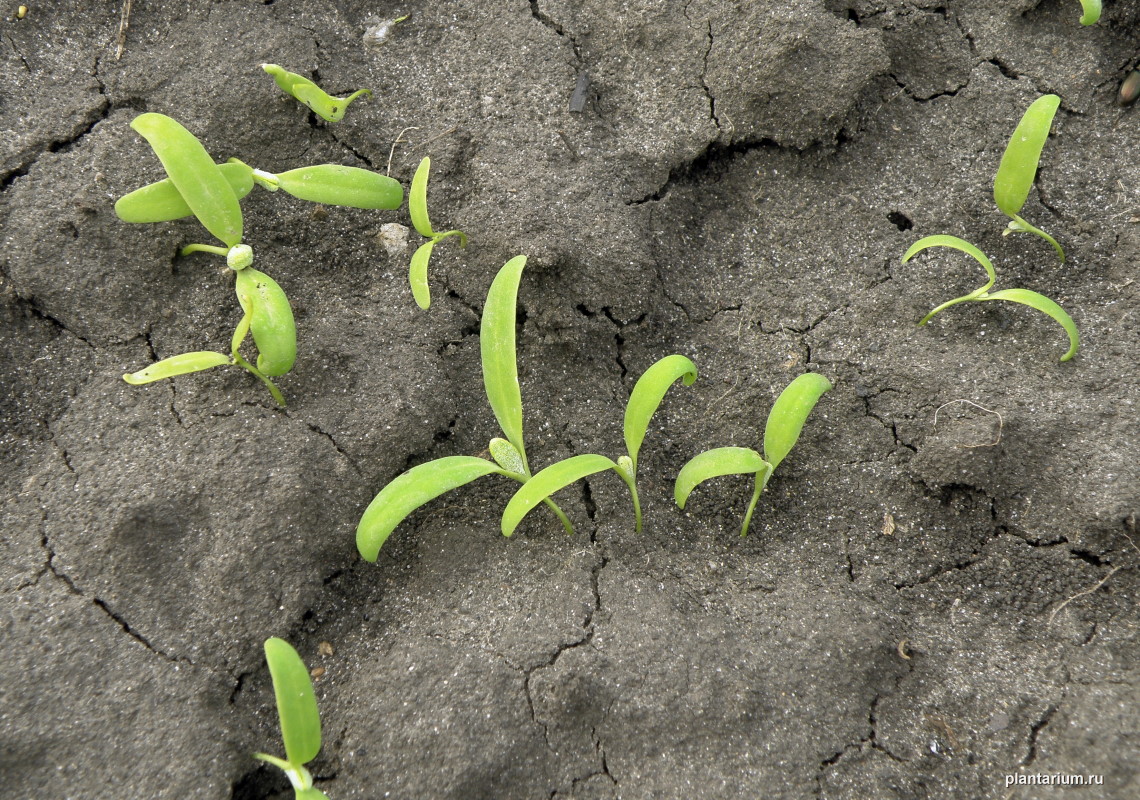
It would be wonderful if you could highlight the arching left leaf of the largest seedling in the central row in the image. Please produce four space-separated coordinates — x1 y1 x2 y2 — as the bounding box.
357 456 506 561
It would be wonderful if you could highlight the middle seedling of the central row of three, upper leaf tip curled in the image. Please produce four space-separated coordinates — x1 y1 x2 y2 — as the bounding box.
502 356 697 536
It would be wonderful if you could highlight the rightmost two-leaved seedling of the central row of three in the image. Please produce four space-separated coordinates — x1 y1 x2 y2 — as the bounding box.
673 373 831 536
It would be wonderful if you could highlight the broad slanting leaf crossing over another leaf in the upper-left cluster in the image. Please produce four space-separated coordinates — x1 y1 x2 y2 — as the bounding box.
131 113 242 247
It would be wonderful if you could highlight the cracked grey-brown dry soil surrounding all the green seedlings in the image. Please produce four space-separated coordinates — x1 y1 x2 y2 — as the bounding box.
0 0 1140 800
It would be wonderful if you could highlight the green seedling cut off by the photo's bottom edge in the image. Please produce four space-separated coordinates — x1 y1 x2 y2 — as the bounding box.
253 637 328 800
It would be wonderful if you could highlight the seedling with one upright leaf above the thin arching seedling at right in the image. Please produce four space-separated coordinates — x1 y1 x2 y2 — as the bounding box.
994 95 1065 263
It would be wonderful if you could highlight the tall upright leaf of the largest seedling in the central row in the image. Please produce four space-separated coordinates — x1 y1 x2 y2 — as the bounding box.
479 255 527 464
